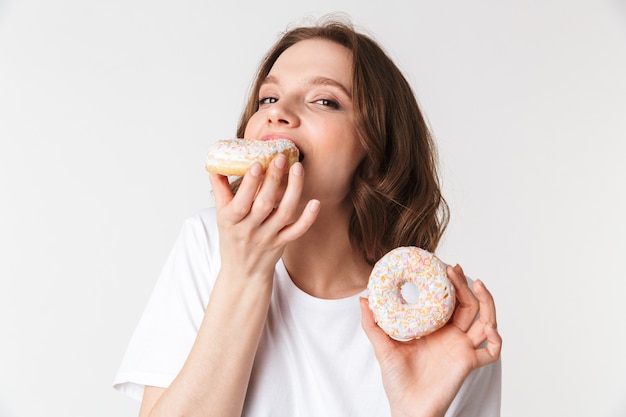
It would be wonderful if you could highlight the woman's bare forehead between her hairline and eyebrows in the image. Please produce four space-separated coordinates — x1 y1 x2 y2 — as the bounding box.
269 39 352 90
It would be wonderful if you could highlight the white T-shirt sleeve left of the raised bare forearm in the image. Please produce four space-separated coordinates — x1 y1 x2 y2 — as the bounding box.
113 209 219 400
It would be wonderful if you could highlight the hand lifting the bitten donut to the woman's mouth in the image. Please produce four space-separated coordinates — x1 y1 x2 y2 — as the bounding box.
210 148 319 277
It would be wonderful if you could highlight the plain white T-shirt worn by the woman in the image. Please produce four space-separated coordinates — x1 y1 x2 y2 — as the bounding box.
114 209 501 417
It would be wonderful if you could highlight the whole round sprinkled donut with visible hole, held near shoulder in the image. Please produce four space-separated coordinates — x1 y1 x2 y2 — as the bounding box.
367 246 456 341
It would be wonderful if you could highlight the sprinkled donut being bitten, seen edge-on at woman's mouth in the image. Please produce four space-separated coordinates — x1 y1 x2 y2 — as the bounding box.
205 139 300 176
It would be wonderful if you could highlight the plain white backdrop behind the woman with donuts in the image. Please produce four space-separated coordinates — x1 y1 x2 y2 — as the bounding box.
0 0 626 417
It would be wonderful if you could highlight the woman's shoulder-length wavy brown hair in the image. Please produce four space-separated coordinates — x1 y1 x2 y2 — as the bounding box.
237 20 449 264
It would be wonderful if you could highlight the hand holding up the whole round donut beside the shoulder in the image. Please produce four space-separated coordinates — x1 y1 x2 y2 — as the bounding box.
361 265 502 416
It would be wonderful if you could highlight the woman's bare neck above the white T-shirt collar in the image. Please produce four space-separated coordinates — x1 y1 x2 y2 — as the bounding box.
283 202 372 299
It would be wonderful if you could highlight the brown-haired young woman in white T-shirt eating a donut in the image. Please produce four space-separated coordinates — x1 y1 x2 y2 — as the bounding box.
116 18 501 417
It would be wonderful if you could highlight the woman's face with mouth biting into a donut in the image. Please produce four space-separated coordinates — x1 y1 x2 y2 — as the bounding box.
245 39 365 204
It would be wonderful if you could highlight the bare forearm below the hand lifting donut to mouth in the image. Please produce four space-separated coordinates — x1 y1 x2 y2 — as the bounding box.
150 274 272 417
